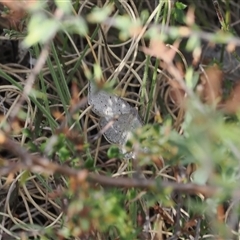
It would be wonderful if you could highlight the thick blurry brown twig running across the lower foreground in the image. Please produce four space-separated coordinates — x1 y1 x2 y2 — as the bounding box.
0 131 219 197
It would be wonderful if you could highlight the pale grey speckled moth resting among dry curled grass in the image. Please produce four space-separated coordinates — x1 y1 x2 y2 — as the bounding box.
88 82 143 158
